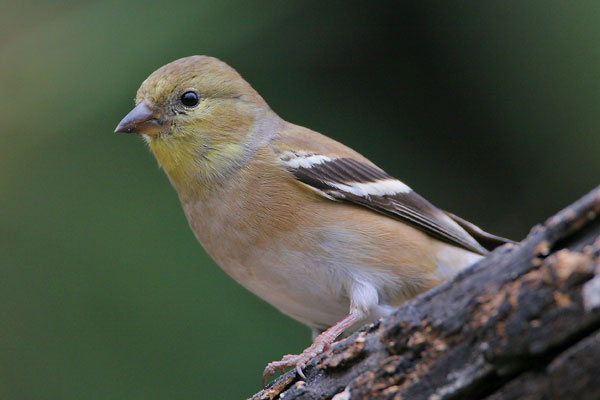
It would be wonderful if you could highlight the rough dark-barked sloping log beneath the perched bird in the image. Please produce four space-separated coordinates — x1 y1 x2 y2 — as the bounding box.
252 187 600 400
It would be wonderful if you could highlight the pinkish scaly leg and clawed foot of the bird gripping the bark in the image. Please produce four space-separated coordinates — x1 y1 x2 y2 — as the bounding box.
263 310 364 386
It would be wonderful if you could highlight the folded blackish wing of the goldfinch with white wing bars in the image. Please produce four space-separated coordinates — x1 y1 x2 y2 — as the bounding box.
279 151 507 254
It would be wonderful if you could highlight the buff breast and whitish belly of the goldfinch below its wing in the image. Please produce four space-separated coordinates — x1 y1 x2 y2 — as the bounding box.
173 155 468 329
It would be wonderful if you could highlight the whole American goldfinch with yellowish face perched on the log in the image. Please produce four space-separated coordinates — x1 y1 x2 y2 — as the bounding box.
115 56 507 382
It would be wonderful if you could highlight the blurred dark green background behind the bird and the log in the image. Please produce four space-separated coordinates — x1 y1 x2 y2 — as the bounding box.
0 0 600 399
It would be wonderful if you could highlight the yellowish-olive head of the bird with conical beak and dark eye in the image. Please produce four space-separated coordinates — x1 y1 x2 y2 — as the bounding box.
115 56 275 192
